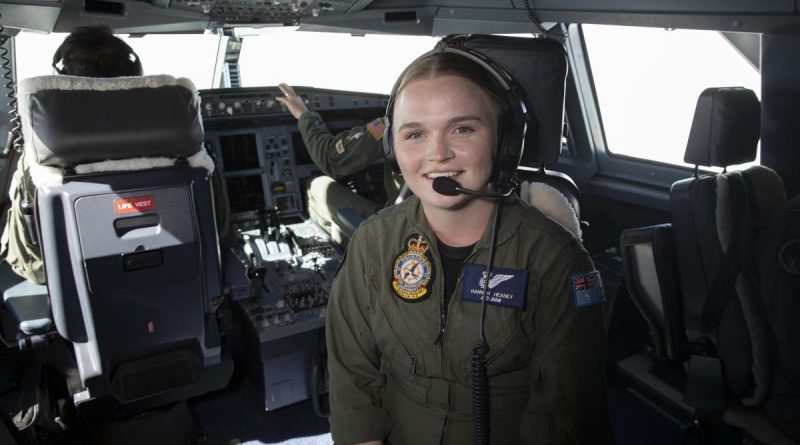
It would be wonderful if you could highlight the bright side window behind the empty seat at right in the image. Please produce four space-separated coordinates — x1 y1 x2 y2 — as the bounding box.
583 25 761 169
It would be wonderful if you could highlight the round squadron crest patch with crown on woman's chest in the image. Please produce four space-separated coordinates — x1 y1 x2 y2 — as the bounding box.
392 234 435 303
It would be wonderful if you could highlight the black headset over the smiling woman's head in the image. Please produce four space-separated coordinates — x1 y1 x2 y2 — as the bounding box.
383 42 528 191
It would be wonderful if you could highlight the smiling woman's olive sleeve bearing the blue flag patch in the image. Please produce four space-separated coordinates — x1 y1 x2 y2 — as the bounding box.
520 246 613 444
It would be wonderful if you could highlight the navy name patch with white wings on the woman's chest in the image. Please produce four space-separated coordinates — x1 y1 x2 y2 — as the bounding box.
461 263 528 309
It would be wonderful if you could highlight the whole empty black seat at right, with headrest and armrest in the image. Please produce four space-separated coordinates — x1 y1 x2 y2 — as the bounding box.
622 88 791 443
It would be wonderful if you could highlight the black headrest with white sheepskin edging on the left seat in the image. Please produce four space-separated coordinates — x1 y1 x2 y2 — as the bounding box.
19 75 203 167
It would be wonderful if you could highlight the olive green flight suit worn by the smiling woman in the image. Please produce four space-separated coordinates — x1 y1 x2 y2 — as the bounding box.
326 197 613 445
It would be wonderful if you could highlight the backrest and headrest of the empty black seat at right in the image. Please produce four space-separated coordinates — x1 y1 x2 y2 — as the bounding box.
670 88 785 405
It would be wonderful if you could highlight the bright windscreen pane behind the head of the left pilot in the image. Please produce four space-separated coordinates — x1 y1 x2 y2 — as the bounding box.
15 32 220 88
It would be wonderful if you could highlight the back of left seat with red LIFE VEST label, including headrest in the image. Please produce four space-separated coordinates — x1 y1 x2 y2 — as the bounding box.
20 76 232 410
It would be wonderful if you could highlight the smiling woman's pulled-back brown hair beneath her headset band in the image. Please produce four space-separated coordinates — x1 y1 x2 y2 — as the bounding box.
392 52 508 116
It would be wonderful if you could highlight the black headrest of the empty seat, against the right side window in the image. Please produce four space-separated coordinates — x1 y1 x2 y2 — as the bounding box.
683 87 761 167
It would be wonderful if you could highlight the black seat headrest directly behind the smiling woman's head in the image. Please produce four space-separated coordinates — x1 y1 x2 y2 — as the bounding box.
447 34 567 167
